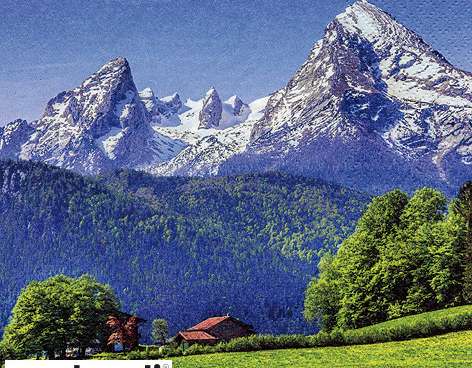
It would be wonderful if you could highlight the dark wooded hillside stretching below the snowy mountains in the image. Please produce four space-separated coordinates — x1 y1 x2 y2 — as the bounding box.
0 161 369 340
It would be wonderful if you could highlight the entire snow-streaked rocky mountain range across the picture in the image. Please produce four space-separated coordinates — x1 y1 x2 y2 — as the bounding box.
0 0 472 194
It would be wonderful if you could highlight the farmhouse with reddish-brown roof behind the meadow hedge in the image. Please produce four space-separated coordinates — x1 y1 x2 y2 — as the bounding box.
176 315 255 345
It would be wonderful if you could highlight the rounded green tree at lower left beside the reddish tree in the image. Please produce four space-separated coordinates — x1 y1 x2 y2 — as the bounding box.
4 275 119 359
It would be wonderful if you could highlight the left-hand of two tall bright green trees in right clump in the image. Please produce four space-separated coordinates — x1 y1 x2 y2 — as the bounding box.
337 190 408 328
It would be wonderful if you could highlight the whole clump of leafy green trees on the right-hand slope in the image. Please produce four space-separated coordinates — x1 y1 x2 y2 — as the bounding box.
305 183 472 330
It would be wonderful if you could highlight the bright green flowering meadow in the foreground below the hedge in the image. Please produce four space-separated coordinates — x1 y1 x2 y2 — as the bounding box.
172 331 472 368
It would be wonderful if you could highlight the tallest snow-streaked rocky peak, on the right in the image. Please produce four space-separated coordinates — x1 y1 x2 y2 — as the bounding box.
220 1 472 192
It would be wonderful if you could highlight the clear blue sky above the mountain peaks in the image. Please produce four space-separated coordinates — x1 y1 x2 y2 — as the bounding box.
0 0 472 124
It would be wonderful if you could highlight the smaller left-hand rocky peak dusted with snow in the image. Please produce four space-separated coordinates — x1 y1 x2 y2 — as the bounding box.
0 58 184 174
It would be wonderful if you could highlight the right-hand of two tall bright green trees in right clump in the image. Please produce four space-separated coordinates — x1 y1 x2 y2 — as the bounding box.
375 188 447 319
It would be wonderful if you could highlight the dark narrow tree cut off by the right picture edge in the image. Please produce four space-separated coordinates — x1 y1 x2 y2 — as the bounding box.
454 181 472 303
